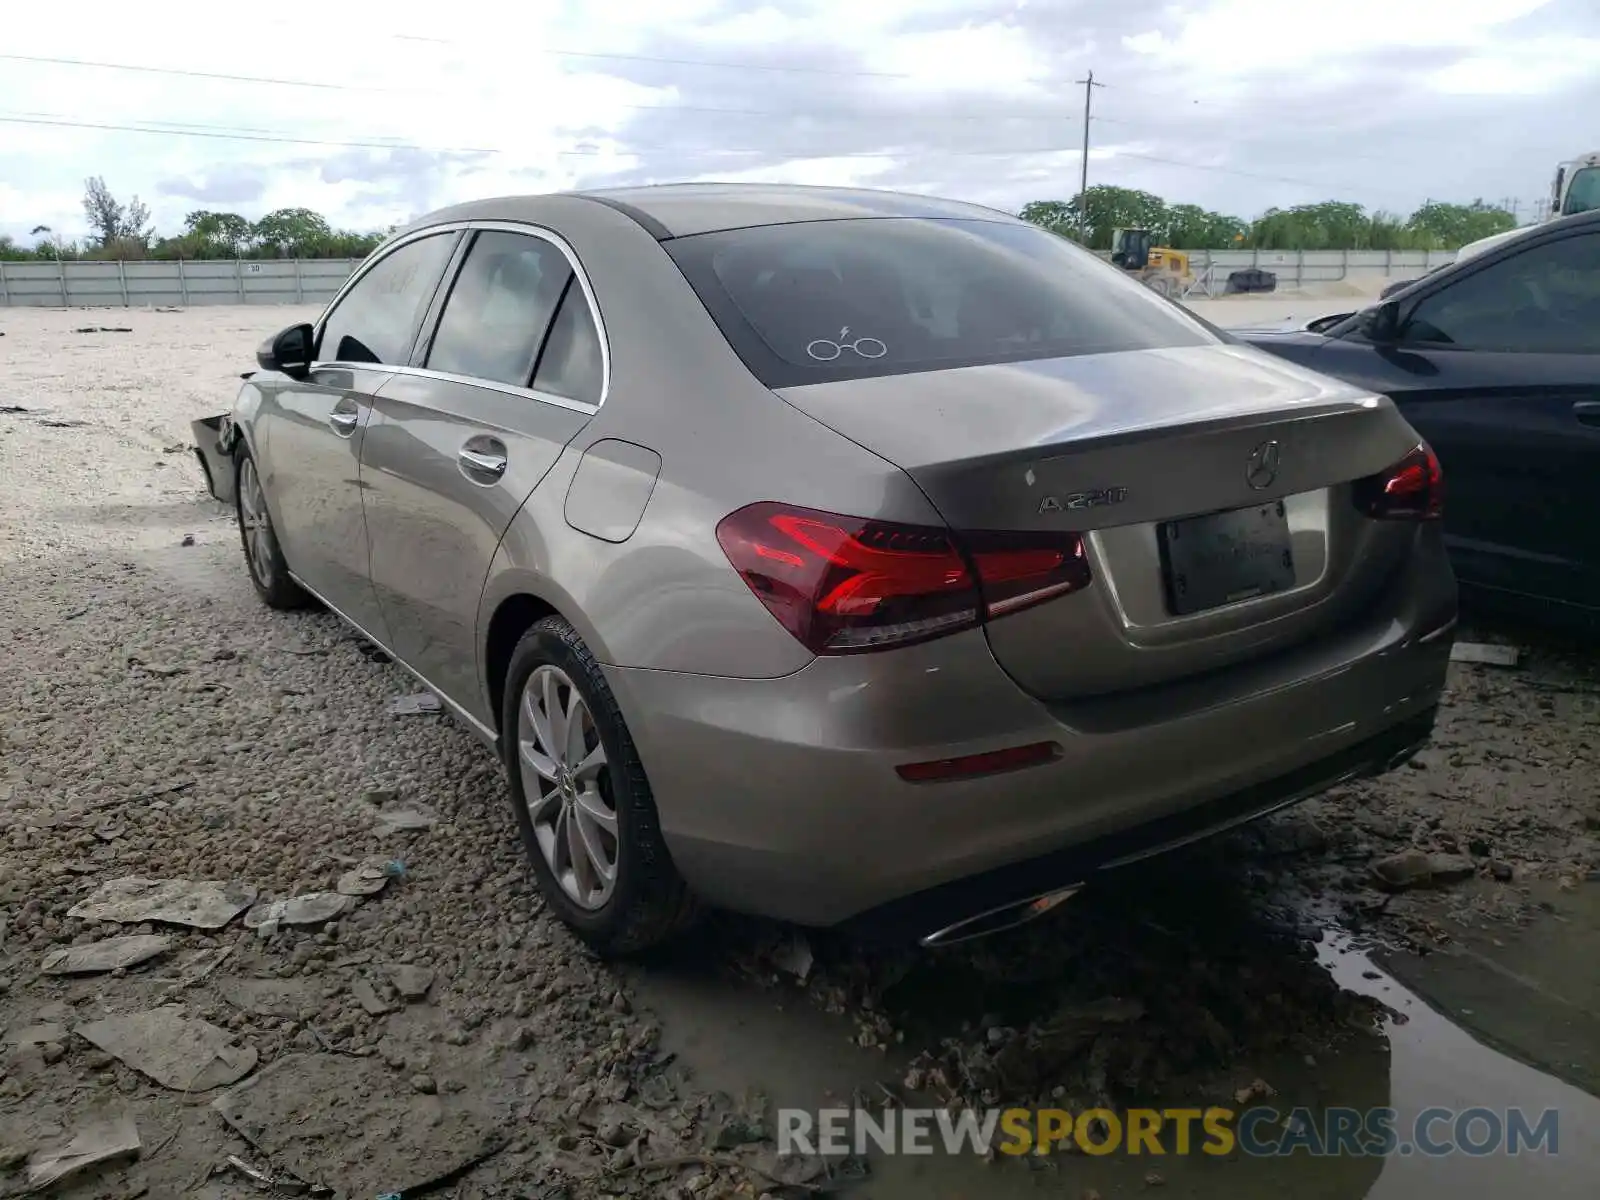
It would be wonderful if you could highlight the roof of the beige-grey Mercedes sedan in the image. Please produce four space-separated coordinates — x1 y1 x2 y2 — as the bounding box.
411 182 1021 242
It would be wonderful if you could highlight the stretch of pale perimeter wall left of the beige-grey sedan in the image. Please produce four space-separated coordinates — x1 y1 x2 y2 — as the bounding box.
0 258 358 307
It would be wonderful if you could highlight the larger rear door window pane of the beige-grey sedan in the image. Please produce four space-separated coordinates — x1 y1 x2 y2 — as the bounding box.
427 230 573 387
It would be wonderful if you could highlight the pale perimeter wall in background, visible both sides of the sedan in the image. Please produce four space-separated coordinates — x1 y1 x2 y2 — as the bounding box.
0 250 1456 307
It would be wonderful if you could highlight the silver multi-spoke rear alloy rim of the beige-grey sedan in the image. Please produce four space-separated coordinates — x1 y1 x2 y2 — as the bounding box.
517 664 619 910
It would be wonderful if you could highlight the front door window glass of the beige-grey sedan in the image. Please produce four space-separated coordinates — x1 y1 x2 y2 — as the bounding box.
317 232 456 365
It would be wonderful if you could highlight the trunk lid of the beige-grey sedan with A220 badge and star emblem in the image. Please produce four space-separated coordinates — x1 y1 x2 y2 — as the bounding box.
779 346 1418 698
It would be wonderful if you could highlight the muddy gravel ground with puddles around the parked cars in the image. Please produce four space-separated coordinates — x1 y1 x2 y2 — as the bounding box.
0 301 1600 1200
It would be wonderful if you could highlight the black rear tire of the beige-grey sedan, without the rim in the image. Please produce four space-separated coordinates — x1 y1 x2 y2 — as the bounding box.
501 621 653 941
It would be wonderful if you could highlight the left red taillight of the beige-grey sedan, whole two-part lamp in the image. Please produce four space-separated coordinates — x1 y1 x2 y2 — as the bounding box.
717 501 1090 654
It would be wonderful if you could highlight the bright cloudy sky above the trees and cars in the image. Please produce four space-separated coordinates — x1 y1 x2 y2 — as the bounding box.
0 0 1600 242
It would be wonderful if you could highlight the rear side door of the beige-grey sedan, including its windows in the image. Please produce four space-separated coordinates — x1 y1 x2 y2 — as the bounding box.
362 226 606 728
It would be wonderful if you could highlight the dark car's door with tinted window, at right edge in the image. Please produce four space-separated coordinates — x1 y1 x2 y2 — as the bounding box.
1376 230 1600 606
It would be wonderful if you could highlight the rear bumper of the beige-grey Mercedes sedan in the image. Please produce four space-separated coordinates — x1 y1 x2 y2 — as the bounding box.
608 536 1456 933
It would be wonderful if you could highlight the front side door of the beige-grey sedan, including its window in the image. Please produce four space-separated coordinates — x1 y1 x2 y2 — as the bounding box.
256 230 461 640
